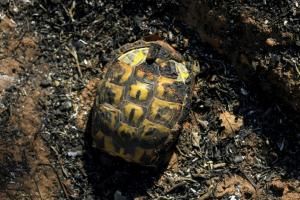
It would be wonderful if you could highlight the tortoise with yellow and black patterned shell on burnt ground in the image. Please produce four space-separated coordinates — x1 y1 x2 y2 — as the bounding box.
91 40 198 167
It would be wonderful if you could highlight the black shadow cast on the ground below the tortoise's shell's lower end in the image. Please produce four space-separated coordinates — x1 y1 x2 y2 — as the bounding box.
83 113 164 200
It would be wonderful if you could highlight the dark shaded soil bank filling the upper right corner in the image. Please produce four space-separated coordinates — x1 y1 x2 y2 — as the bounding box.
176 0 300 112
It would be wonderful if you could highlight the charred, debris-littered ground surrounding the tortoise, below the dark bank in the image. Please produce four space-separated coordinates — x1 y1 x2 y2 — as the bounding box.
0 0 300 200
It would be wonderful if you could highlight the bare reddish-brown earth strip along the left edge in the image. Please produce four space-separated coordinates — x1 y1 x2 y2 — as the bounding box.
0 14 61 199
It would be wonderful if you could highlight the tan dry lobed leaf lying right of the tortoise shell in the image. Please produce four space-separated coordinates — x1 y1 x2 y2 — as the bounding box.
219 111 243 138
